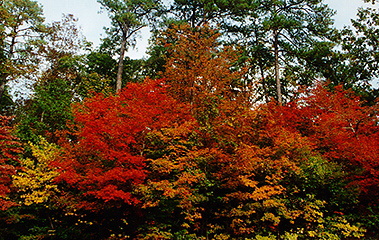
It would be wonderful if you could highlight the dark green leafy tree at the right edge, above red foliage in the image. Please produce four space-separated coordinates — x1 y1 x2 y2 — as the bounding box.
331 3 379 98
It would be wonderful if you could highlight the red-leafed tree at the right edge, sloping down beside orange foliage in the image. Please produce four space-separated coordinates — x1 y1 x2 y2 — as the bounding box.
262 84 379 201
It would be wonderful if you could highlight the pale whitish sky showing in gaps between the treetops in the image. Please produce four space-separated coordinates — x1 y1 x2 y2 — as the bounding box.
37 0 378 59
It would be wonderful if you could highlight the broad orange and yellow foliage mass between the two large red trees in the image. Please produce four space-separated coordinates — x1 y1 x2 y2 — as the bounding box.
137 84 364 239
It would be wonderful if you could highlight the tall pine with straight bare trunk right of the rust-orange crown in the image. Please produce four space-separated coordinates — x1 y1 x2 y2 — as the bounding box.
227 0 333 104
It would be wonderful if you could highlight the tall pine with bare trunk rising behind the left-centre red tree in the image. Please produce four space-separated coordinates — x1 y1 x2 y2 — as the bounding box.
98 0 160 92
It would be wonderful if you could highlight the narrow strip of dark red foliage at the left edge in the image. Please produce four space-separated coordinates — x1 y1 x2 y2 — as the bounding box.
0 116 22 210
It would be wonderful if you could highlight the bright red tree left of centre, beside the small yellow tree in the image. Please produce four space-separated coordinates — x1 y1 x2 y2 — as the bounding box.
56 80 193 210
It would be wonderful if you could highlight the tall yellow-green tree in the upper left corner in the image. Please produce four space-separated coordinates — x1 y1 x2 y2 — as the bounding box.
0 0 45 108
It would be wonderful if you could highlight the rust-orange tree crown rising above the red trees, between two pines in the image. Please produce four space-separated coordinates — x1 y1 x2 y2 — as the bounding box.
161 24 248 120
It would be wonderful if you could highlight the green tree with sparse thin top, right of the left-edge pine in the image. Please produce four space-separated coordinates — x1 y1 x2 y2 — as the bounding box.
17 15 88 143
